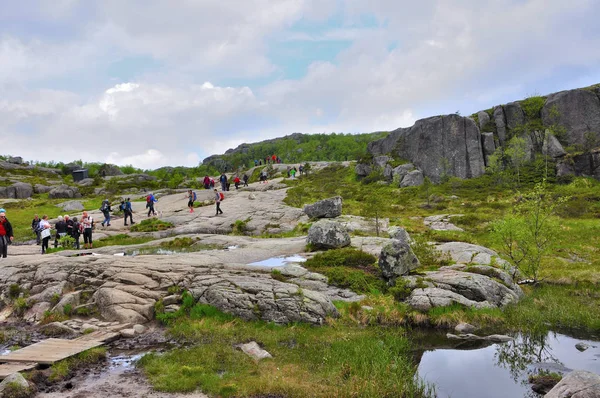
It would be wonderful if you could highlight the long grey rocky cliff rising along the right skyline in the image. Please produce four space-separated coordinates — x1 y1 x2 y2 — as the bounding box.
364 84 600 182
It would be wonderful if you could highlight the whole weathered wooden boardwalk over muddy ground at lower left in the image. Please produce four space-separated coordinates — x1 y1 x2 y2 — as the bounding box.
0 331 119 380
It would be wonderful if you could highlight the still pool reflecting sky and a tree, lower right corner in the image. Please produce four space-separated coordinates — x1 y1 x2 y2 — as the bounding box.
416 333 600 398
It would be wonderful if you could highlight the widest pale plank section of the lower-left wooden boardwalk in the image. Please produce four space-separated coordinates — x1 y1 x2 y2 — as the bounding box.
0 339 104 365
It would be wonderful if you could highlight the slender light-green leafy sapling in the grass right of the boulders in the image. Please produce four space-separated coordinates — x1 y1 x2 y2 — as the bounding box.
492 180 567 282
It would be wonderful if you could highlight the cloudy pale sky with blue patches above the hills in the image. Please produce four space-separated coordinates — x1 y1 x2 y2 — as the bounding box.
0 0 600 169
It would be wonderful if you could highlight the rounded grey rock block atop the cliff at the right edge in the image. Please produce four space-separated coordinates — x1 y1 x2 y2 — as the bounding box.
542 89 600 145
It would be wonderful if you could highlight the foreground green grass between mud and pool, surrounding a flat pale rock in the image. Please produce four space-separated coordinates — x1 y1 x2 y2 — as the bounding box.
139 306 427 397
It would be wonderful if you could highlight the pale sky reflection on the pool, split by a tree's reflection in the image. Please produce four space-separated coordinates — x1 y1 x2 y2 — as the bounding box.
418 334 600 398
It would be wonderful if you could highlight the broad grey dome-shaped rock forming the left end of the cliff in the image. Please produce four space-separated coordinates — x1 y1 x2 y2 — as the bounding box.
368 115 485 182
